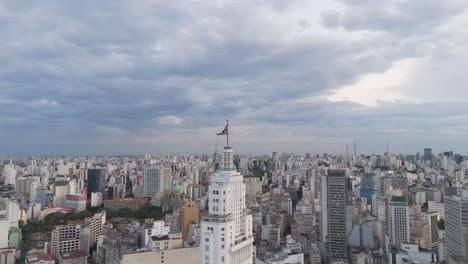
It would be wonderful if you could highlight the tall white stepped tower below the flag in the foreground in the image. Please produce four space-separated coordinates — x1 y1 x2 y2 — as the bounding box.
200 147 254 264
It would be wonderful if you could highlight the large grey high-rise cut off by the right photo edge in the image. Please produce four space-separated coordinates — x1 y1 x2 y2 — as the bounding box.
444 190 468 259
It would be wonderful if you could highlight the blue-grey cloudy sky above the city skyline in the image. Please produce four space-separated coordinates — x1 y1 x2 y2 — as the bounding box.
0 0 468 155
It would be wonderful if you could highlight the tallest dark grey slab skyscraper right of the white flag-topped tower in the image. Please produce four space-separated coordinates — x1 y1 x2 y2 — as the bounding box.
321 170 347 263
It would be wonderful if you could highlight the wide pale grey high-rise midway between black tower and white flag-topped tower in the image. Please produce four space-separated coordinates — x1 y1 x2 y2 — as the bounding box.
143 166 172 197
